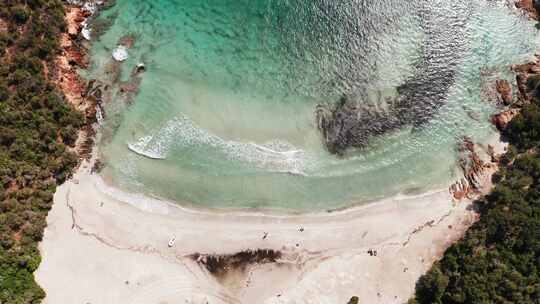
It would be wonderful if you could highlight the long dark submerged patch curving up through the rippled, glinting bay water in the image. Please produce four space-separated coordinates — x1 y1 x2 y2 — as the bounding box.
316 2 468 155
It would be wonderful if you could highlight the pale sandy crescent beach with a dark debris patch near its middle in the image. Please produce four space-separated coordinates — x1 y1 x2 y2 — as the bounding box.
36 1 536 303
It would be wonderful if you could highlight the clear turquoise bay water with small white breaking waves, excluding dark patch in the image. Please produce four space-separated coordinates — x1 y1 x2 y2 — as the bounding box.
88 0 537 211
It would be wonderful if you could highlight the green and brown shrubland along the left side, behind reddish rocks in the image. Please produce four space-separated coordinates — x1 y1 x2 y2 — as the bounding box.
0 0 84 303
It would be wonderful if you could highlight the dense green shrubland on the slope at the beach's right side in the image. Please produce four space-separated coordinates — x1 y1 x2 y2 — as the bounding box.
410 70 540 304
